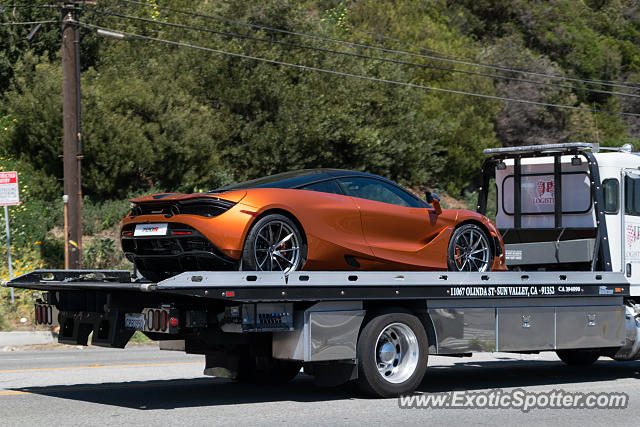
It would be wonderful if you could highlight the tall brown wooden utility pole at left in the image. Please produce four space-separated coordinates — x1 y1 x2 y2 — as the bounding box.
61 1 83 268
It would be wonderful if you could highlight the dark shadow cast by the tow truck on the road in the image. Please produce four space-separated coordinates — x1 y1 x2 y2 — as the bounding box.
13 360 640 410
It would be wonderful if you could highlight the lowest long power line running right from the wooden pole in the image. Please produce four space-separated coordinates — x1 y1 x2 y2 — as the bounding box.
78 23 640 117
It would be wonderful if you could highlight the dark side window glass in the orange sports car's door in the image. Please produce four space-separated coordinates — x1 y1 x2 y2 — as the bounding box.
338 177 422 208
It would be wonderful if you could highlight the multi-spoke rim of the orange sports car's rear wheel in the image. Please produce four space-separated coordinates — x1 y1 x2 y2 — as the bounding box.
253 221 300 273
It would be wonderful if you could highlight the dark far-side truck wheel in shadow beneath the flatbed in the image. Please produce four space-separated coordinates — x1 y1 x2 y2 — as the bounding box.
236 357 302 384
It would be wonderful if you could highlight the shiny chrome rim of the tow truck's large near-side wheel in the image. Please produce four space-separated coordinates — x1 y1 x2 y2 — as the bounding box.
375 323 420 384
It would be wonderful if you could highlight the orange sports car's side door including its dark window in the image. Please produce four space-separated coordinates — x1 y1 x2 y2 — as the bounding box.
337 177 438 265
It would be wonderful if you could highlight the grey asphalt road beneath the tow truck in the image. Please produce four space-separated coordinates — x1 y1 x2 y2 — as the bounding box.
0 346 640 427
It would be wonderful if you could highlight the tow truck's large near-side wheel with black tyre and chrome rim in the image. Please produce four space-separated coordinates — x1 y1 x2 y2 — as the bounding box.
356 310 429 397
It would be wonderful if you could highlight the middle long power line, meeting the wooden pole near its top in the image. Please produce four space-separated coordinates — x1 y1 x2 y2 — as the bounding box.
82 8 640 98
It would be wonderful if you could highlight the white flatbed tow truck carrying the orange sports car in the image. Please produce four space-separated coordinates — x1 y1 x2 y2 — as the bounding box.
5 143 640 397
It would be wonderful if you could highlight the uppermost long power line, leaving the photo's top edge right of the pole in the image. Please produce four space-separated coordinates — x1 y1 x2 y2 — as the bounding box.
120 0 640 90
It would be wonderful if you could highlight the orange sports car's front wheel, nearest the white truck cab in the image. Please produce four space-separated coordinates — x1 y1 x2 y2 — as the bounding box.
447 224 493 271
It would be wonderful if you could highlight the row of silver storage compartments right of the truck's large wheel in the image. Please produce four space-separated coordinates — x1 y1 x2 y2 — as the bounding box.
428 305 625 354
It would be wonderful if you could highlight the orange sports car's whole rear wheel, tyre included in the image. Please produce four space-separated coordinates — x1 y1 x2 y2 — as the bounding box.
241 214 307 274
